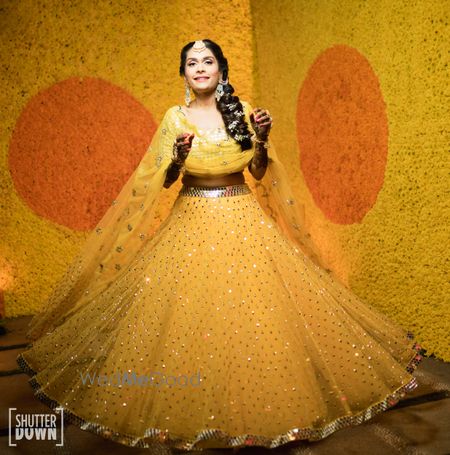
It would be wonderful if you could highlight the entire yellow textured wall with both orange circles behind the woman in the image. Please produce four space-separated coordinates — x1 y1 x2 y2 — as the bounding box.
0 0 450 360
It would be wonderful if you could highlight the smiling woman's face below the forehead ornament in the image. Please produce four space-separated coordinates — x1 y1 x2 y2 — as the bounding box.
184 48 221 93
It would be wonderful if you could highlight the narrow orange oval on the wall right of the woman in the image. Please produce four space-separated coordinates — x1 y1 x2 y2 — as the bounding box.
297 45 388 224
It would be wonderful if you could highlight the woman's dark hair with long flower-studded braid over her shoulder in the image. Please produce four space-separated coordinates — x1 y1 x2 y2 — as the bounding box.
180 39 252 150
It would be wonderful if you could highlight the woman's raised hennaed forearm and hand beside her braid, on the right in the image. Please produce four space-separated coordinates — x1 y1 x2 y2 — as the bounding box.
248 107 272 180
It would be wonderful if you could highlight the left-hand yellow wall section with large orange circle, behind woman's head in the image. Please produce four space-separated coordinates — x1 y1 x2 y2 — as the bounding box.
0 0 253 317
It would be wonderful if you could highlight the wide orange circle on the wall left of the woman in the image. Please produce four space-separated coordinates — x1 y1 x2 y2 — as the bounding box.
9 77 156 230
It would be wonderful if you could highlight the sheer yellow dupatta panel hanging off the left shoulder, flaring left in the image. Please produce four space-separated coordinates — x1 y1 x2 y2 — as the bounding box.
27 111 176 340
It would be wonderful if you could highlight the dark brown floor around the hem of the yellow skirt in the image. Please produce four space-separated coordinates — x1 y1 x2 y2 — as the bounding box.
0 317 450 455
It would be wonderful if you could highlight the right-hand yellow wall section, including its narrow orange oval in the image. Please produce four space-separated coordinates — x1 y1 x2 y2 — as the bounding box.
251 0 450 361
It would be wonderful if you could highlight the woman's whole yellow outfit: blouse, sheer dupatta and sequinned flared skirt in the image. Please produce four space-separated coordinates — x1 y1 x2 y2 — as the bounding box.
18 103 423 450
